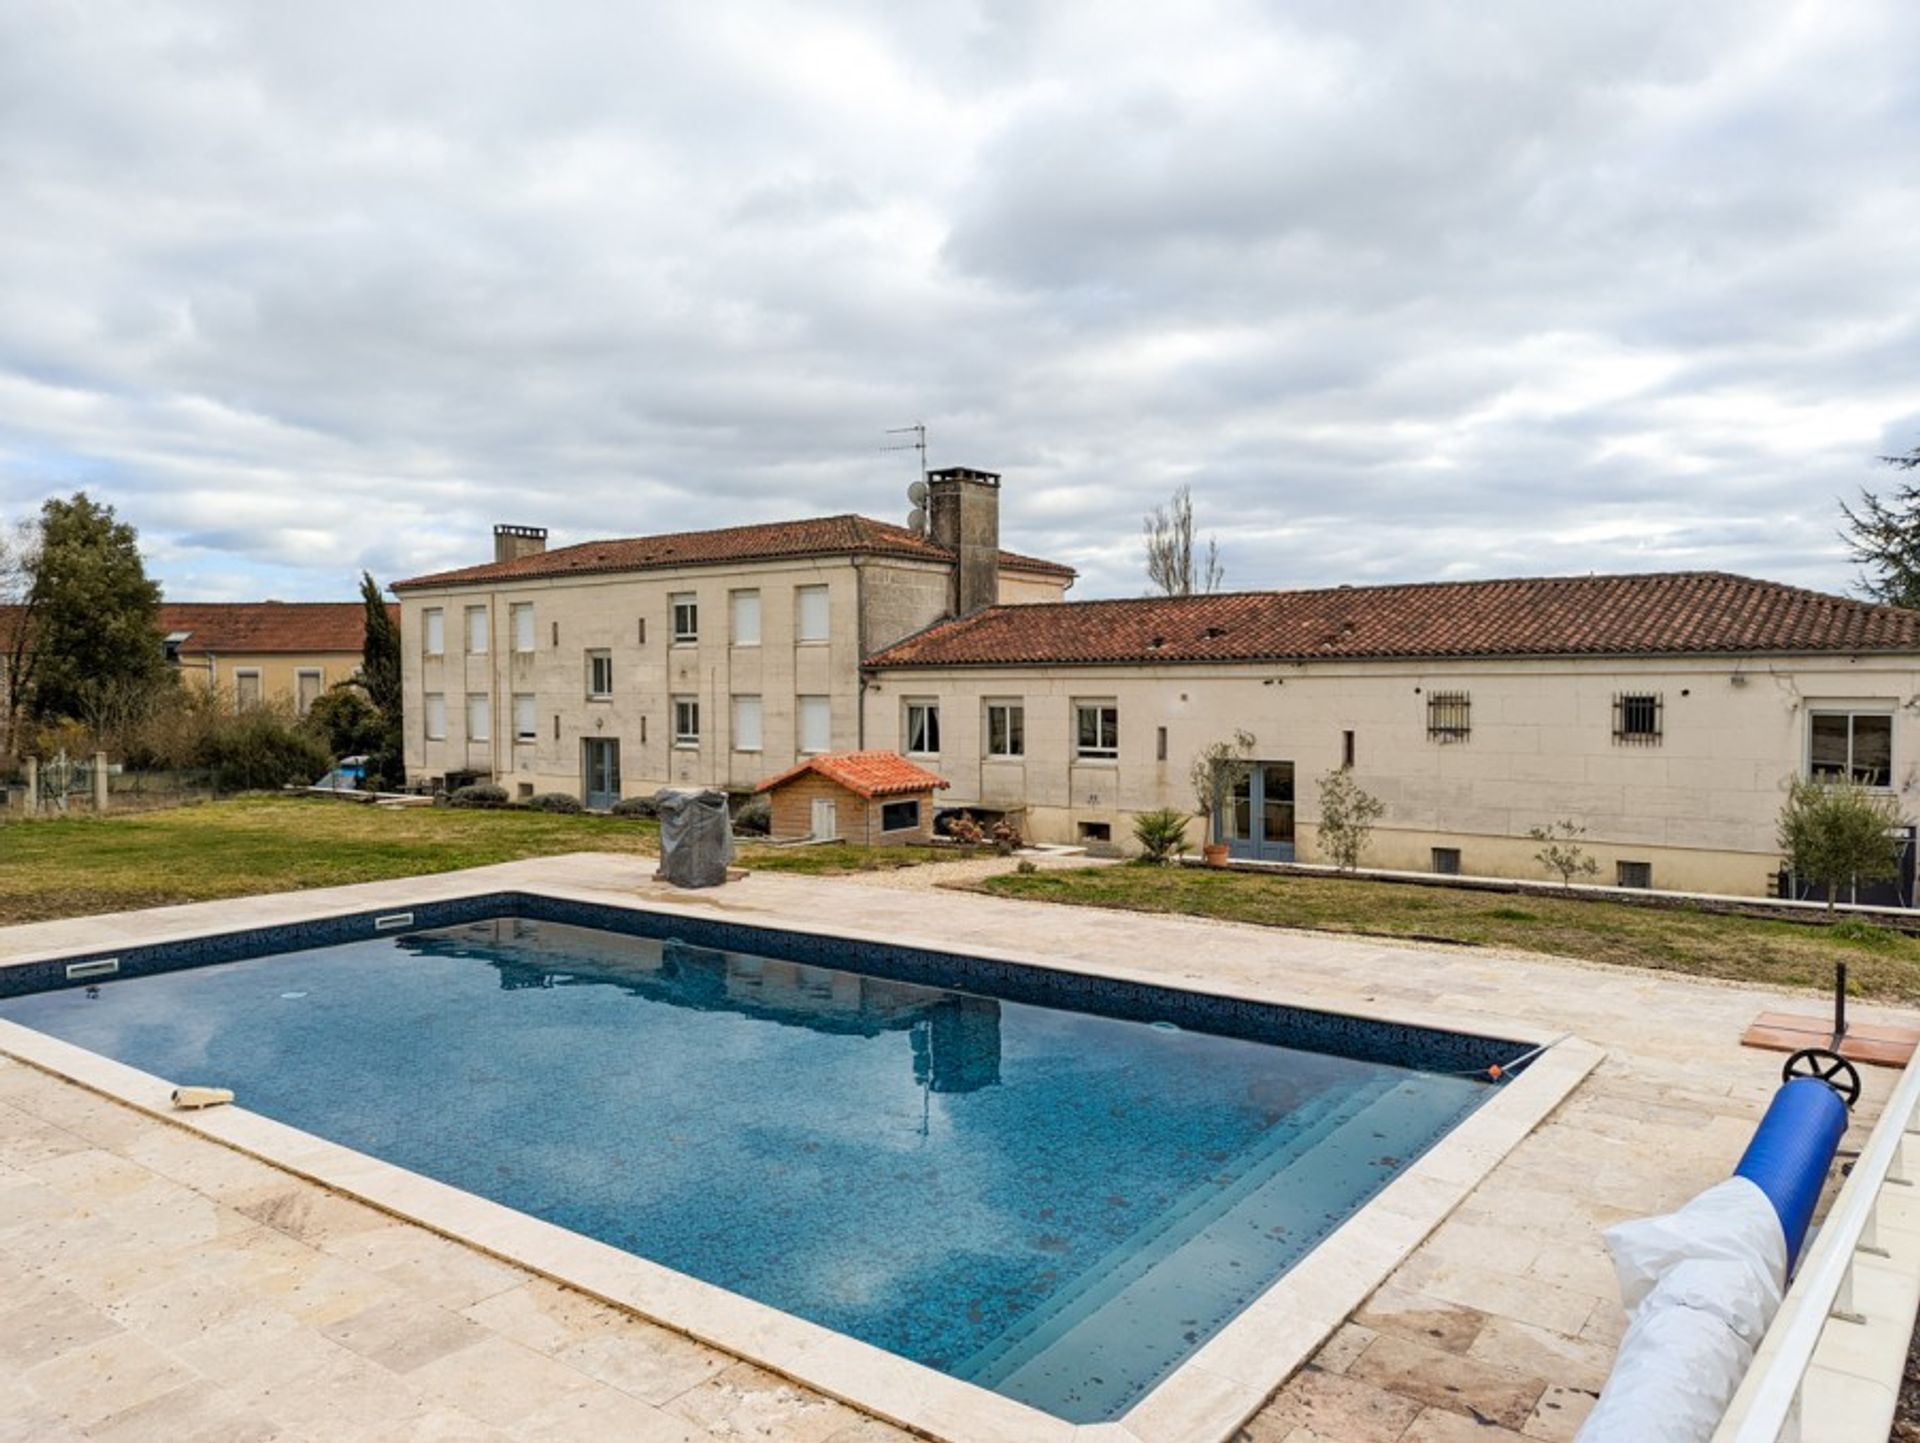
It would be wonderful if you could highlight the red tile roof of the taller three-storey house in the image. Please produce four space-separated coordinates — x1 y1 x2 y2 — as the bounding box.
394 516 1075 591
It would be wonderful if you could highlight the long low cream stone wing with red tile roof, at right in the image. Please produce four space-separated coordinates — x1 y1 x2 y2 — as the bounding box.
866 572 1920 896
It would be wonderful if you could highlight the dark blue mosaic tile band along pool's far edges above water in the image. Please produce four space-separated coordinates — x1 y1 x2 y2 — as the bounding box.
0 892 1526 1073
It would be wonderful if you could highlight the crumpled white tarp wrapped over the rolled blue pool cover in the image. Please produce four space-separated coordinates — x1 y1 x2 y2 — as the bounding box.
1574 1178 1788 1443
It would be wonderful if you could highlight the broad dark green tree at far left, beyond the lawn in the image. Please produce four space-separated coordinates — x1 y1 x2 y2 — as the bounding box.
23 491 175 722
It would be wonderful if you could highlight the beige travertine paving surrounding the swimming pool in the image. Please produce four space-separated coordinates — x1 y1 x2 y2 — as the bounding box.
0 856 1895 1443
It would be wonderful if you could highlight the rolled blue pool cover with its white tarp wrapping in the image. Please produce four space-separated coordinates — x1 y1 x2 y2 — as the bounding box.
1576 1076 1847 1443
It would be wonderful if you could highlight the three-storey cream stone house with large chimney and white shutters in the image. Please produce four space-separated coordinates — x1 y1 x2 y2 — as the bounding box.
394 468 1073 808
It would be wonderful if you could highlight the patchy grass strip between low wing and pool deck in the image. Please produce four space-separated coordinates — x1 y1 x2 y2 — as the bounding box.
973 865 1920 1002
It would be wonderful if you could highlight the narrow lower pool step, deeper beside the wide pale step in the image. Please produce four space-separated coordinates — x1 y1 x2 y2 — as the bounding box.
954 1076 1394 1385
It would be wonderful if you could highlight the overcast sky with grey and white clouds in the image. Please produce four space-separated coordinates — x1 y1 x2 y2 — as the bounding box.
0 0 1920 599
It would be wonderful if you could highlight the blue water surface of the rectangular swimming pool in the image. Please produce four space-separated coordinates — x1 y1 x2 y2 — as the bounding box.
0 917 1488 1422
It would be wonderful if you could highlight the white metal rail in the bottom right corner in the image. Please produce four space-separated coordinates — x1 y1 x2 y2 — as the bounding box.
1713 1055 1920 1443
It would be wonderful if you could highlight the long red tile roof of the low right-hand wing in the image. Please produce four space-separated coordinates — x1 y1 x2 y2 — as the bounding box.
868 572 1920 668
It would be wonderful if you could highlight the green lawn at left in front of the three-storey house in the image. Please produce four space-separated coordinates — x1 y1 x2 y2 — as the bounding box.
0 796 659 925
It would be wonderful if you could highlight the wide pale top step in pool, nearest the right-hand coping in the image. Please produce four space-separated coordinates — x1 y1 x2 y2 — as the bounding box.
962 1078 1463 1416
